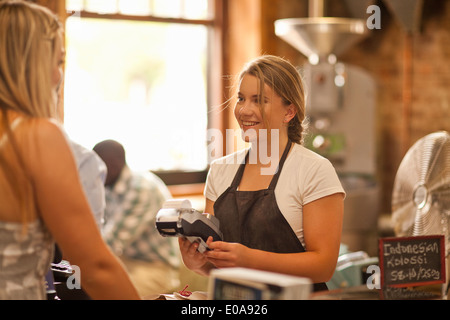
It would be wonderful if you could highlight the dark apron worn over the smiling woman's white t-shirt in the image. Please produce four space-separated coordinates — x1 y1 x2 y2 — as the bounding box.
214 141 328 291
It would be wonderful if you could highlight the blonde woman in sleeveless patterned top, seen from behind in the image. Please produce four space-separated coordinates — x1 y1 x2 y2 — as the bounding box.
0 0 139 299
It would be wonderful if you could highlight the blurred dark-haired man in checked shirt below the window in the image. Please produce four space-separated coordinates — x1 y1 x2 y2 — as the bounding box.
94 140 180 297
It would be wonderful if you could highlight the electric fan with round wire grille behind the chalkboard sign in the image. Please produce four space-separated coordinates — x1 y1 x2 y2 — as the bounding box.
392 131 450 255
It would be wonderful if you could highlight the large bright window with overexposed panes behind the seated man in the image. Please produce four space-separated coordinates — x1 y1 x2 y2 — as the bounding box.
64 0 220 180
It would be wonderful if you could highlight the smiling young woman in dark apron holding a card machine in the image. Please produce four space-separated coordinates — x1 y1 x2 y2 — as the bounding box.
179 55 345 291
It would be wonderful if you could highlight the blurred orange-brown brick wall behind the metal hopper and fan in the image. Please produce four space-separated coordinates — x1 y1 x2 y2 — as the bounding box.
262 0 450 214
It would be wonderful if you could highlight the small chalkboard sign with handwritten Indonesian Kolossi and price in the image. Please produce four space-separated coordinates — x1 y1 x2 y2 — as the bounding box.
379 235 445 287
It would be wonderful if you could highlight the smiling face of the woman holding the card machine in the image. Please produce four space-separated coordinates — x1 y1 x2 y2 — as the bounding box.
234 74 295 142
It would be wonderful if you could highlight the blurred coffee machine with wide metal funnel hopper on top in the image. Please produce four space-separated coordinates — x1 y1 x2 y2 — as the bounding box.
275 1 379 254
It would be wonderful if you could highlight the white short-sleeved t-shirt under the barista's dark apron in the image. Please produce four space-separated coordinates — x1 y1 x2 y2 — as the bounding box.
204 144 345 249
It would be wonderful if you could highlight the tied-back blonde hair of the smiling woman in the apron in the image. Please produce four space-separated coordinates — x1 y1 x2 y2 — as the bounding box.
238 55 307 144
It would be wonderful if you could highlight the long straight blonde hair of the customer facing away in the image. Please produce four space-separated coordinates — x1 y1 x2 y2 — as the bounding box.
0 0 62 117
